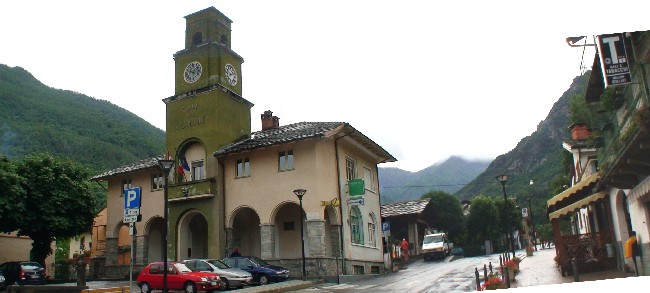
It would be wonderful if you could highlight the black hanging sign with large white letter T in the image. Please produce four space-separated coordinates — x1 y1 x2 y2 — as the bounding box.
597 34 632 87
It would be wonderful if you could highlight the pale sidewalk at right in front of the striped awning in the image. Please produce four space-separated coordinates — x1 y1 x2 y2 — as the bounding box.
511 248 632 291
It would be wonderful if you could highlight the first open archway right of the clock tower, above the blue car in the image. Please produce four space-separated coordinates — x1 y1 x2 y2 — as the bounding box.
229 207 262 257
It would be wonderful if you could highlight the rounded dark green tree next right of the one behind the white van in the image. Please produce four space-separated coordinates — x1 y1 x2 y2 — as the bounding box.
467 195 499 244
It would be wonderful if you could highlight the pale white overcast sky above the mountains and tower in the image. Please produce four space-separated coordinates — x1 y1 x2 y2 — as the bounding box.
0 0 650 171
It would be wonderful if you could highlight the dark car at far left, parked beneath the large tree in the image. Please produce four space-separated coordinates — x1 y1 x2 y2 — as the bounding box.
0 261 46 286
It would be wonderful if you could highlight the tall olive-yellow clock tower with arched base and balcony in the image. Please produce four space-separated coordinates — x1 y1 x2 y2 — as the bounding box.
163 7 253 259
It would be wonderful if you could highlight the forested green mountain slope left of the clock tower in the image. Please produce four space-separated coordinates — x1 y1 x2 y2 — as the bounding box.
0 64 165 172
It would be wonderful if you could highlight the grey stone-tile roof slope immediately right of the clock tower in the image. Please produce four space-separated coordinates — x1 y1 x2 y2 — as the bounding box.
214 122 347 157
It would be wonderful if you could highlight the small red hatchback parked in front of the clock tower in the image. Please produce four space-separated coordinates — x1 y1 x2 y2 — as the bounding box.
137 262 221 293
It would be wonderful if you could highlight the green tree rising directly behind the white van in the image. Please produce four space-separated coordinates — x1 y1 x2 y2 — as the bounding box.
421 191 466 242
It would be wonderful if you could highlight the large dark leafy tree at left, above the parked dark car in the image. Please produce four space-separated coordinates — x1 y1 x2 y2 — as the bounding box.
14 154 97 265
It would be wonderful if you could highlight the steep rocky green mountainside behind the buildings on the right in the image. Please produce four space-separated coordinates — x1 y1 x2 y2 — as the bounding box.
456 74 589 203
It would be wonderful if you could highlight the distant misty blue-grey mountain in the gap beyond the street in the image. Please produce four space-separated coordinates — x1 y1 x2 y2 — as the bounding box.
378 156 490 204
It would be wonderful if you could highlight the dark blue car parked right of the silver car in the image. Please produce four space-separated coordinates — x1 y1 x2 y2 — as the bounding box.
222 256 289 285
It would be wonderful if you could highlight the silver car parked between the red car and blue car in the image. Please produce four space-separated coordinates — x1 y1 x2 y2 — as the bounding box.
183 259 253 290
